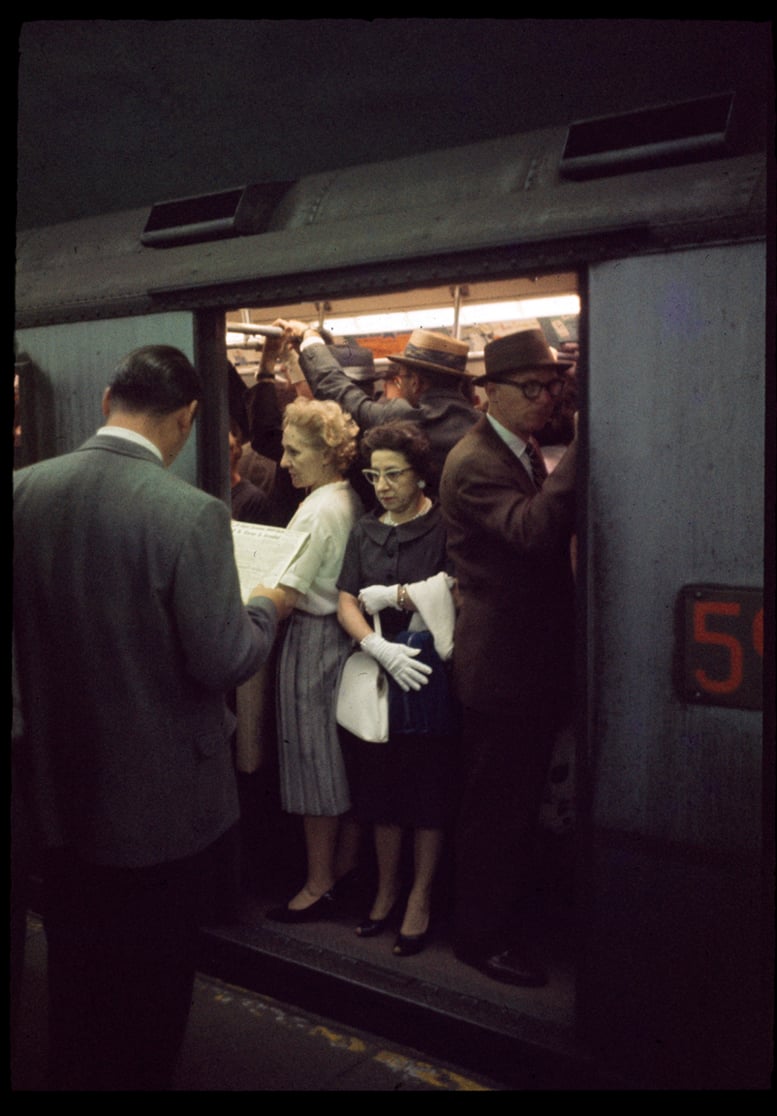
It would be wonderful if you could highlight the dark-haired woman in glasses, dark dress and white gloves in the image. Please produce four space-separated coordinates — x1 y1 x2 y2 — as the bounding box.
337 422 455 956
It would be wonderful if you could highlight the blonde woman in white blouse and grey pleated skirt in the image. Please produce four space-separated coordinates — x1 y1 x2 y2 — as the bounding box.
267 397 364 923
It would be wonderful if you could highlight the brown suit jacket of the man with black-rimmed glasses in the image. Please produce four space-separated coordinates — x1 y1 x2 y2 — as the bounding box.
440 416 577 723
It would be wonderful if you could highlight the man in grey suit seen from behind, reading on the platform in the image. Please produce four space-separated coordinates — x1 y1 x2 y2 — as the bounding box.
13 345 284 1090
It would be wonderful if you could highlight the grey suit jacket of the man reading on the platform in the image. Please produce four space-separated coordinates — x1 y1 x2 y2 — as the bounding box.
13 434 277 866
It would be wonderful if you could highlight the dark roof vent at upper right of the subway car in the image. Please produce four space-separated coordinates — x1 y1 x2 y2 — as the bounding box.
559 93 733 179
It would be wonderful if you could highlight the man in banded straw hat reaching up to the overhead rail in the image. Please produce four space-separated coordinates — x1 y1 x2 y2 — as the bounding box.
276 320 480 477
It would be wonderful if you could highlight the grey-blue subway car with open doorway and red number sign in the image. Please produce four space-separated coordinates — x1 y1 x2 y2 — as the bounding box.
15 94 775 1090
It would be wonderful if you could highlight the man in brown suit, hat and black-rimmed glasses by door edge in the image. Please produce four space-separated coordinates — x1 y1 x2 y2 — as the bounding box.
440 329 576 987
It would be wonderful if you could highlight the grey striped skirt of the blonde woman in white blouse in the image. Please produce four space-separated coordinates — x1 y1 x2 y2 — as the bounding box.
278 609 351 817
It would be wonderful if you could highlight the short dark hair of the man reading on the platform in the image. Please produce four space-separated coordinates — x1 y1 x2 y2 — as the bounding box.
111 345 202 415
